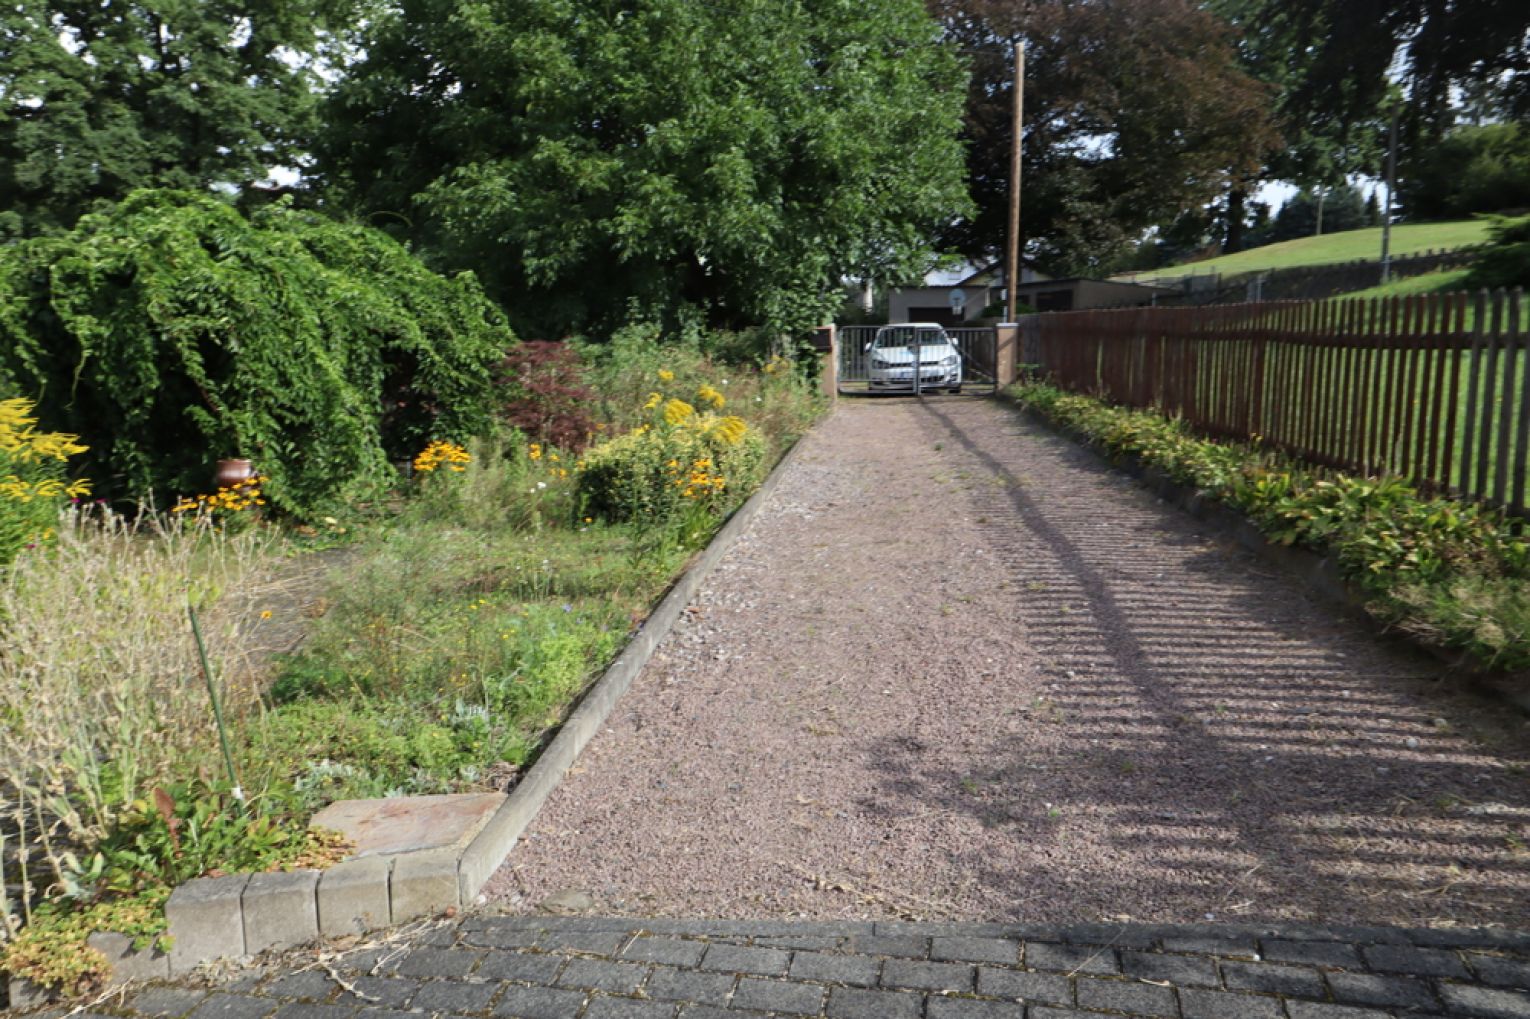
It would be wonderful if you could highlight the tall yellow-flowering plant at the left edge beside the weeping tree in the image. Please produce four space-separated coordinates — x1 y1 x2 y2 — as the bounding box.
0 398 90 566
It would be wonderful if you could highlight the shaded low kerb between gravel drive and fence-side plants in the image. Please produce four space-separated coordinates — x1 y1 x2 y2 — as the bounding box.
998 389 1530 715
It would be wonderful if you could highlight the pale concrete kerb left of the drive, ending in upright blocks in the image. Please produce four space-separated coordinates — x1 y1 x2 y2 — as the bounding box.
11 412 832 1007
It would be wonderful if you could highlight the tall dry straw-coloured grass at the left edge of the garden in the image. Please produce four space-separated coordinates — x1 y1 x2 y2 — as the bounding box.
0 508 280 932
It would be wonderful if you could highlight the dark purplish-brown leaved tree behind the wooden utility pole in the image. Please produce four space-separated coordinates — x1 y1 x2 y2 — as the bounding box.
930 0 1274 272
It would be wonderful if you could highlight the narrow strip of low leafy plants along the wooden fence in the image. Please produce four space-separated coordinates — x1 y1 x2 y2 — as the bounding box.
1007 383 1530 682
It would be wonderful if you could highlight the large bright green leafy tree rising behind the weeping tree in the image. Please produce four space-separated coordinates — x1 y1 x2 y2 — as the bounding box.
320 0 965 335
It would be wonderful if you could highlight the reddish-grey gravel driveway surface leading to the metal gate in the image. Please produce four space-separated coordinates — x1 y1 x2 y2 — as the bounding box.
485 396 1530 929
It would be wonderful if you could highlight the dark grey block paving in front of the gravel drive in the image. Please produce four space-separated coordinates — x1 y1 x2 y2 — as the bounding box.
86 915 1530 1019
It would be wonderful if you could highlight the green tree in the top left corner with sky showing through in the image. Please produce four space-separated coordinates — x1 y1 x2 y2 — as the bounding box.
0 0 340 237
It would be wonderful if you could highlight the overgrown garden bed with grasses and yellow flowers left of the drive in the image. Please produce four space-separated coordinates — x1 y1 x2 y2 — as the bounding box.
6 335 819 993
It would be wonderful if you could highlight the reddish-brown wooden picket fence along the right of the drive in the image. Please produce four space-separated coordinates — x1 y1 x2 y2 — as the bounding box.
1037 289 1530 514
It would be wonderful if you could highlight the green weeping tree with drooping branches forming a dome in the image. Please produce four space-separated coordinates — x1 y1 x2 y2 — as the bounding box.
0 191 514 514
